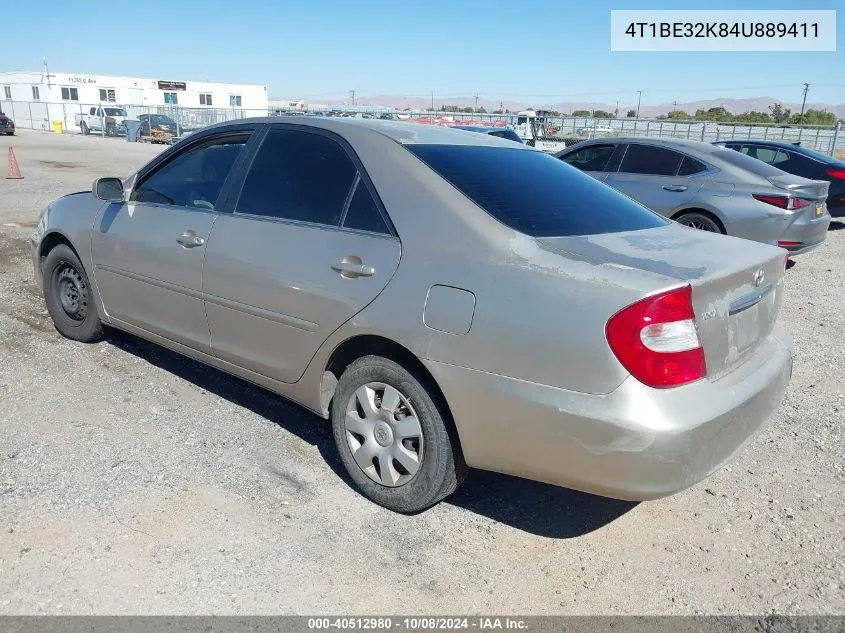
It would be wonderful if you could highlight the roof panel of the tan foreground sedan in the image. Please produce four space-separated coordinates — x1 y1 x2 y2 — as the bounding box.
203 116 535 151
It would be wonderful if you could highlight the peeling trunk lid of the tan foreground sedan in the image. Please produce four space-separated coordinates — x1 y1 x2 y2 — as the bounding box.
538 224 786 380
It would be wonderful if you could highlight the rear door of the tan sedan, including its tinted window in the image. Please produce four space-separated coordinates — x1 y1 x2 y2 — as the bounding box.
203 125 400 382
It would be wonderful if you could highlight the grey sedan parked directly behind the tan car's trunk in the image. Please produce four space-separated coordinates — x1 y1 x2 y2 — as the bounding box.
556 138 830 255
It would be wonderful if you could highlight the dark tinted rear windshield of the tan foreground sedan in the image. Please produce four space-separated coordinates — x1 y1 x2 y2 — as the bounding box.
405 145 668 237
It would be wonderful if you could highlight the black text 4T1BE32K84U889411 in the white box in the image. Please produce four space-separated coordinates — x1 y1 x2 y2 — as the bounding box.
625 22 819 38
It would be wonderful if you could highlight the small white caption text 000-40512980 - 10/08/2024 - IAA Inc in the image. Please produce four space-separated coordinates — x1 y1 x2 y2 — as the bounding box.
308 617 527 631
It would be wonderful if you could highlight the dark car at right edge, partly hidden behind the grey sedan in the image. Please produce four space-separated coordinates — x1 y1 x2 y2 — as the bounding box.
714 140 845 217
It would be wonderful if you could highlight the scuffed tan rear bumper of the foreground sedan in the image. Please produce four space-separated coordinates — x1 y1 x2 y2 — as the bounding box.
424 328 792 501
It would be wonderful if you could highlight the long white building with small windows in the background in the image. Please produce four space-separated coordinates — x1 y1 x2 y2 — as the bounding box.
0 71 269 128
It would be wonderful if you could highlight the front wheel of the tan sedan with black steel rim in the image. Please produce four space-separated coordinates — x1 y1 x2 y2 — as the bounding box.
42 244 103 343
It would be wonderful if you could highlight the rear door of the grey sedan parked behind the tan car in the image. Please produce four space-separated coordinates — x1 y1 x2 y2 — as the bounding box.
605 143 707 217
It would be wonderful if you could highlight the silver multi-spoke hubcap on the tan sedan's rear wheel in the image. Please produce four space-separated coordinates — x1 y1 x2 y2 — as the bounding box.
345 382 423 488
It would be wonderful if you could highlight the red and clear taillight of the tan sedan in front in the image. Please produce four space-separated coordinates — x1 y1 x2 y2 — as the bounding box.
605 286 707 388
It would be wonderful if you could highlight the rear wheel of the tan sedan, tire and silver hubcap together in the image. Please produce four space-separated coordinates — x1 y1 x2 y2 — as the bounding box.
332 356 467 513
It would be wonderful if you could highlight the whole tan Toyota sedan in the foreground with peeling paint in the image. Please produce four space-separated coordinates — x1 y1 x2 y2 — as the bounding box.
32 117 792 512
